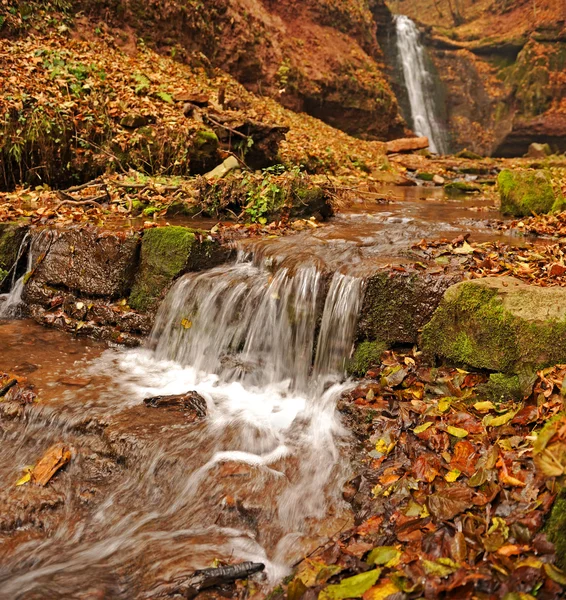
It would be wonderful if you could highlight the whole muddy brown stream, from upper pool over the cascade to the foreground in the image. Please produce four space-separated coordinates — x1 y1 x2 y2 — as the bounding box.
0 188 532 599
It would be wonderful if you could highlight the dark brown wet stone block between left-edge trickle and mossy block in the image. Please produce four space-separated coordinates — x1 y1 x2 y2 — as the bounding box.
24 228 139 301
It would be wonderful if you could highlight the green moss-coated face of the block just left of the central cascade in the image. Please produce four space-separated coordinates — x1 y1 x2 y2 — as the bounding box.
128 227 196 311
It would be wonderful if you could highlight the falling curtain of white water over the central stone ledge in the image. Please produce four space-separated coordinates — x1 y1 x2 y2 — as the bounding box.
151 253 362 391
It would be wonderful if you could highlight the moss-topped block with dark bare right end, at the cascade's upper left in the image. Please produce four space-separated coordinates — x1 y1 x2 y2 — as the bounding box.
129 227 229 311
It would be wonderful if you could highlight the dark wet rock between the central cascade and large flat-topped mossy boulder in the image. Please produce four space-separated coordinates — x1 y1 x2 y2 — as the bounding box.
357 271 461 344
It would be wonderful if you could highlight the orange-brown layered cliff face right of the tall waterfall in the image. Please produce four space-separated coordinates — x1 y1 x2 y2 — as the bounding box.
390 0 566 156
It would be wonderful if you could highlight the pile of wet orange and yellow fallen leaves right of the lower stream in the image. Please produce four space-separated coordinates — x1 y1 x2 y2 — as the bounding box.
286 353 566 600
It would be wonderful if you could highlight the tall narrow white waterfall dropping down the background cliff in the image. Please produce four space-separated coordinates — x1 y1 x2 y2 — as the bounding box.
395 15 447 154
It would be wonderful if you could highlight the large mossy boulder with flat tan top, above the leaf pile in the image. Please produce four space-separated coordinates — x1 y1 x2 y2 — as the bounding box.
422 277 566 374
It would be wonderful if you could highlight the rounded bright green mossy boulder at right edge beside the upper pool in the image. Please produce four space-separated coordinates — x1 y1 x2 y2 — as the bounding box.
497 169 566 217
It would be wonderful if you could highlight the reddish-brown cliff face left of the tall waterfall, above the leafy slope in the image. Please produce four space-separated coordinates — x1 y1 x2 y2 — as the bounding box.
64 0 404 139
